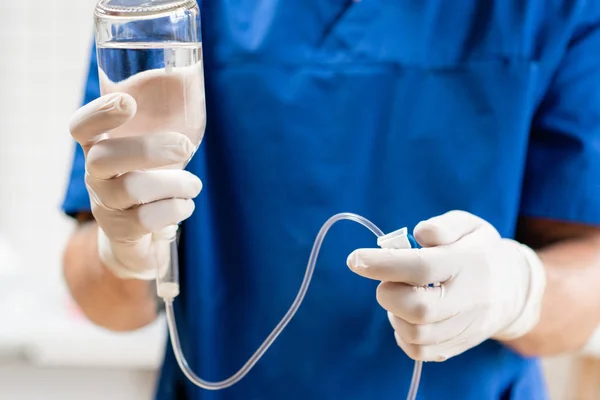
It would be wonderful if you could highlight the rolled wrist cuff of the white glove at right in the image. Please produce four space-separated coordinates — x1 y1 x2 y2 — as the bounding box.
494 242 546 341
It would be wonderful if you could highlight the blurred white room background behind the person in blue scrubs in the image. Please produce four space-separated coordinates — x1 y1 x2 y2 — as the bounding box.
0 0 596 400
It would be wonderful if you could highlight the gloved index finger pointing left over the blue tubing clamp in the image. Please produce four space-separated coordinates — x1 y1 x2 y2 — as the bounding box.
348 247 460 286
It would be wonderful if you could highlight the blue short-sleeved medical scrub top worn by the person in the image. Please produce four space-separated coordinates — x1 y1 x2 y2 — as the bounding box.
64 0 600 400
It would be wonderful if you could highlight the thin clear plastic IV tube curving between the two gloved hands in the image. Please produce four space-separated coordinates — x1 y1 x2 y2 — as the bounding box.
157 213 423 400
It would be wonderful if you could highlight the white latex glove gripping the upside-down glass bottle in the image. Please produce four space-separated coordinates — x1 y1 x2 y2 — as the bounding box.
70 93 202 280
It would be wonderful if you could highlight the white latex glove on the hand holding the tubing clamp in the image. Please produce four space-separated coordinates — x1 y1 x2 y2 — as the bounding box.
348 211 546 361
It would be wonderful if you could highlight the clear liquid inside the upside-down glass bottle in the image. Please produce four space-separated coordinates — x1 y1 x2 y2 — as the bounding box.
97 42 206 168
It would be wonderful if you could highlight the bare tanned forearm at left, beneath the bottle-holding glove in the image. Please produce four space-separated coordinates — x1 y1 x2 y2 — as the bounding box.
64 222 156 331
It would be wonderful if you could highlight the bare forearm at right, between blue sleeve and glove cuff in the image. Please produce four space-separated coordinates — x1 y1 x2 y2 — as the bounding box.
508 223 600 356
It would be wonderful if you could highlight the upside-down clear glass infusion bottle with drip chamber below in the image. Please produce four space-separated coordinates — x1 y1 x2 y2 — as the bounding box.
94 0 206 297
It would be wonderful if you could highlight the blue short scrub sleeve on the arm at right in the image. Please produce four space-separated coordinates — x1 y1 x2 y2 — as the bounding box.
521 13 600 225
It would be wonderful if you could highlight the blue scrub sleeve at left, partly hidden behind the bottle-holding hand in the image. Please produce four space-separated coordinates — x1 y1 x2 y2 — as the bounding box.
62 42 100 215
